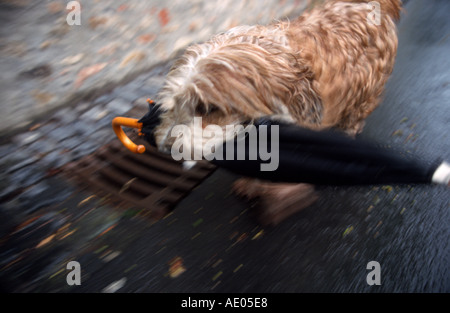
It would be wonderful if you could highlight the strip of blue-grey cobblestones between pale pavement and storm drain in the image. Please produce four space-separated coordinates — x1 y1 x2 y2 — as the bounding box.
0 63 170 212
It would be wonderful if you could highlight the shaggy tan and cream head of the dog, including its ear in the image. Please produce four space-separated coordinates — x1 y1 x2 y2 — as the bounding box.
154 28 322 152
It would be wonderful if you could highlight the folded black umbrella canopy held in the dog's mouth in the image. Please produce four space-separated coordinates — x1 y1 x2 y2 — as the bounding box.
118 101 450 185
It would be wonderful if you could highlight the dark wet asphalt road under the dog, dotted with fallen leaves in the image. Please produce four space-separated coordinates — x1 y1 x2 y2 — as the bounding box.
2 0 450 292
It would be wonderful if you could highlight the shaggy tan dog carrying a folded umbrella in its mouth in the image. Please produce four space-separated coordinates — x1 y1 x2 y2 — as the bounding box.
154 0 401 224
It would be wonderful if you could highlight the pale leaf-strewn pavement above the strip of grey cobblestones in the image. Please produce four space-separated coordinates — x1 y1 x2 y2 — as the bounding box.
0 0 307 134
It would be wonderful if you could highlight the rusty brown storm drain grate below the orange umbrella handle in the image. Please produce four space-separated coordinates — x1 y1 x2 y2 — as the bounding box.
66 138 215 219
